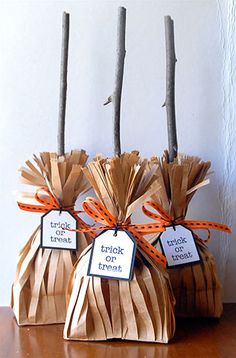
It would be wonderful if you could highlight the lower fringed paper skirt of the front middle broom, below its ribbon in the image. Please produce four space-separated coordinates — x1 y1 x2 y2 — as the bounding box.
64 246 175 343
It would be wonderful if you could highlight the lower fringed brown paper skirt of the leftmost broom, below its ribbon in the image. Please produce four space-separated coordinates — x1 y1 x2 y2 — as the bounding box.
11 226 88 325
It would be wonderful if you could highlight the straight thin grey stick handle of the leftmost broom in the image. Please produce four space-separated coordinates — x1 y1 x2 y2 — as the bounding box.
57 12 70 155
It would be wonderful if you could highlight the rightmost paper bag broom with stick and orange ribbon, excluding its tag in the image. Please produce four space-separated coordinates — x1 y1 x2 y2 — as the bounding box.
144 16 230 317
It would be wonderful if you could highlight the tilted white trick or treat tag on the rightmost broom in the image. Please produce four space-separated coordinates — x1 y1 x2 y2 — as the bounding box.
159 225 200 267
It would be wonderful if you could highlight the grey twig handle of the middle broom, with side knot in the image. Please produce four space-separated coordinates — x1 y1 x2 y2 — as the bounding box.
104 7 126 155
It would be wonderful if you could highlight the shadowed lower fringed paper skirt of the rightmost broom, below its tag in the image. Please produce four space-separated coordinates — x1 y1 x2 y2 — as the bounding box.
169 240 223 318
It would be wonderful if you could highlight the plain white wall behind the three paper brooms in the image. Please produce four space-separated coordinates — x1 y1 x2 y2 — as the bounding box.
0 0 236 305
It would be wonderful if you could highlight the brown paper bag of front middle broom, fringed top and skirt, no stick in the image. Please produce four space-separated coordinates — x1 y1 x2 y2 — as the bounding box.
64 152 175 343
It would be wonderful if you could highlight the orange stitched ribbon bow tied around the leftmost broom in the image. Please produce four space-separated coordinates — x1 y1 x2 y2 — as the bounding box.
17 187 94 236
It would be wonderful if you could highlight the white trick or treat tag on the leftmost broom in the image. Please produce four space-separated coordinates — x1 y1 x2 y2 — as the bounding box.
41 209 78 250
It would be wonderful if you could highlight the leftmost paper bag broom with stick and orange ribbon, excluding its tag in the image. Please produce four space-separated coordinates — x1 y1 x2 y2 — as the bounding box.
11 13 90 325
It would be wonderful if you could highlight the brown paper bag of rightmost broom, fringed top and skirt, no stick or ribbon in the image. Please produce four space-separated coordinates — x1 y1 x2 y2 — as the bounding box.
148 152 228 317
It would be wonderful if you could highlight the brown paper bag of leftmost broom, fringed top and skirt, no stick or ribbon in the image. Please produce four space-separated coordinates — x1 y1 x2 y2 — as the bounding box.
11 150 90 325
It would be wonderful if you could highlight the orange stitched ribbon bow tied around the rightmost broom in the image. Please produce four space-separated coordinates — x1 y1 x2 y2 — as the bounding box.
142 201 232 242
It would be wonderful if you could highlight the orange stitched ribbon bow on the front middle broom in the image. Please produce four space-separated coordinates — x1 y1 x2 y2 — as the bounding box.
69 197 166 267
